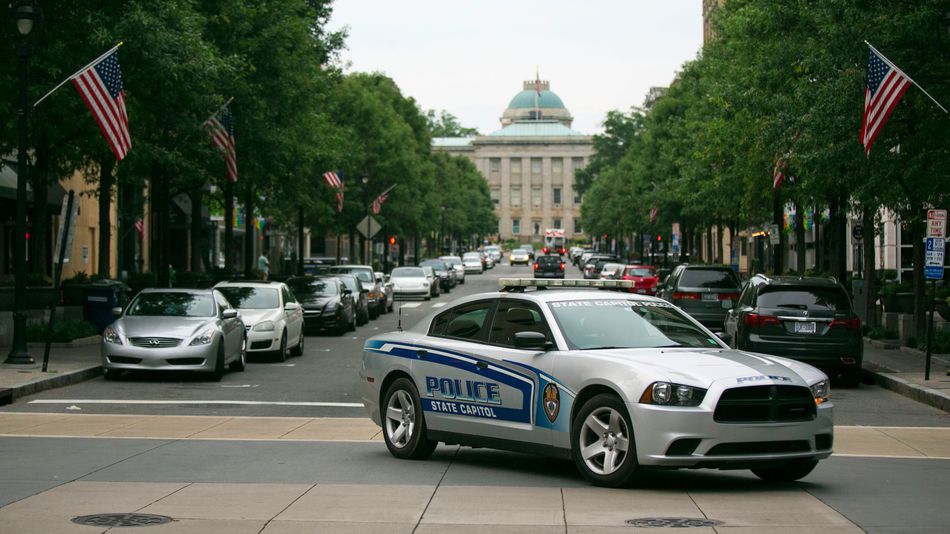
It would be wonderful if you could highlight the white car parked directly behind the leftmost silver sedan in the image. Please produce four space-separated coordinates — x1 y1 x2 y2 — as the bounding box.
214 282 306 361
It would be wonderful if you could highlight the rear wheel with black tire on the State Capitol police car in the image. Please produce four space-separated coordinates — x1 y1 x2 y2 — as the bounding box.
380 378 439 460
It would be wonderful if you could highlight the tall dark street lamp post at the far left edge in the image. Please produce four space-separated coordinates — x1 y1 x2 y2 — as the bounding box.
4 0 40 364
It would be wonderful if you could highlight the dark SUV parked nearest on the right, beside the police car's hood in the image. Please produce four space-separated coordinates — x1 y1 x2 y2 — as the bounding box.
725 275 864 387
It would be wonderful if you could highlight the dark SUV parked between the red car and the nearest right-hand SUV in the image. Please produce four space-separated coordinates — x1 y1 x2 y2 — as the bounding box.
656 264 740 332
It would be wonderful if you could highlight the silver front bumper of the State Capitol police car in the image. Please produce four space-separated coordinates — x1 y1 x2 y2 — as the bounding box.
628 402 834 469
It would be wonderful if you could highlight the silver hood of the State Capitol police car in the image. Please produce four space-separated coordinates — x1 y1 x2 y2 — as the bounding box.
588 348 827 388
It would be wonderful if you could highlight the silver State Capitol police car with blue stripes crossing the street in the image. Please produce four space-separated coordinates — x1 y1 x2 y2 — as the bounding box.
360 278 834 486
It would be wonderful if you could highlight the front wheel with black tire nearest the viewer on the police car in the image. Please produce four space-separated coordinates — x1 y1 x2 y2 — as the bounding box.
571 393 642 488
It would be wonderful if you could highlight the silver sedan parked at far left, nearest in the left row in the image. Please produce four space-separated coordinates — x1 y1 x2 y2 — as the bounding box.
101 289 246 380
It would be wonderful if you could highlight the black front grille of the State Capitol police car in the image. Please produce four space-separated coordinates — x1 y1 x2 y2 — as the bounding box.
713 386 818 423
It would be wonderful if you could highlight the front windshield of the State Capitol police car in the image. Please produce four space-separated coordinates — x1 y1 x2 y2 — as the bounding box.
548 299 720 350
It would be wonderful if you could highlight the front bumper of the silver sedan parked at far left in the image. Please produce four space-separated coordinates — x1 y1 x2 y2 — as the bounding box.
99 338 220 372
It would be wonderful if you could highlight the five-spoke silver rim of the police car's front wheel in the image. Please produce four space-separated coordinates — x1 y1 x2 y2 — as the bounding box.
578 406 630 476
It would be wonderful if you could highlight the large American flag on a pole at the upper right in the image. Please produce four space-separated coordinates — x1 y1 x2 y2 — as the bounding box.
861 46 910 156
